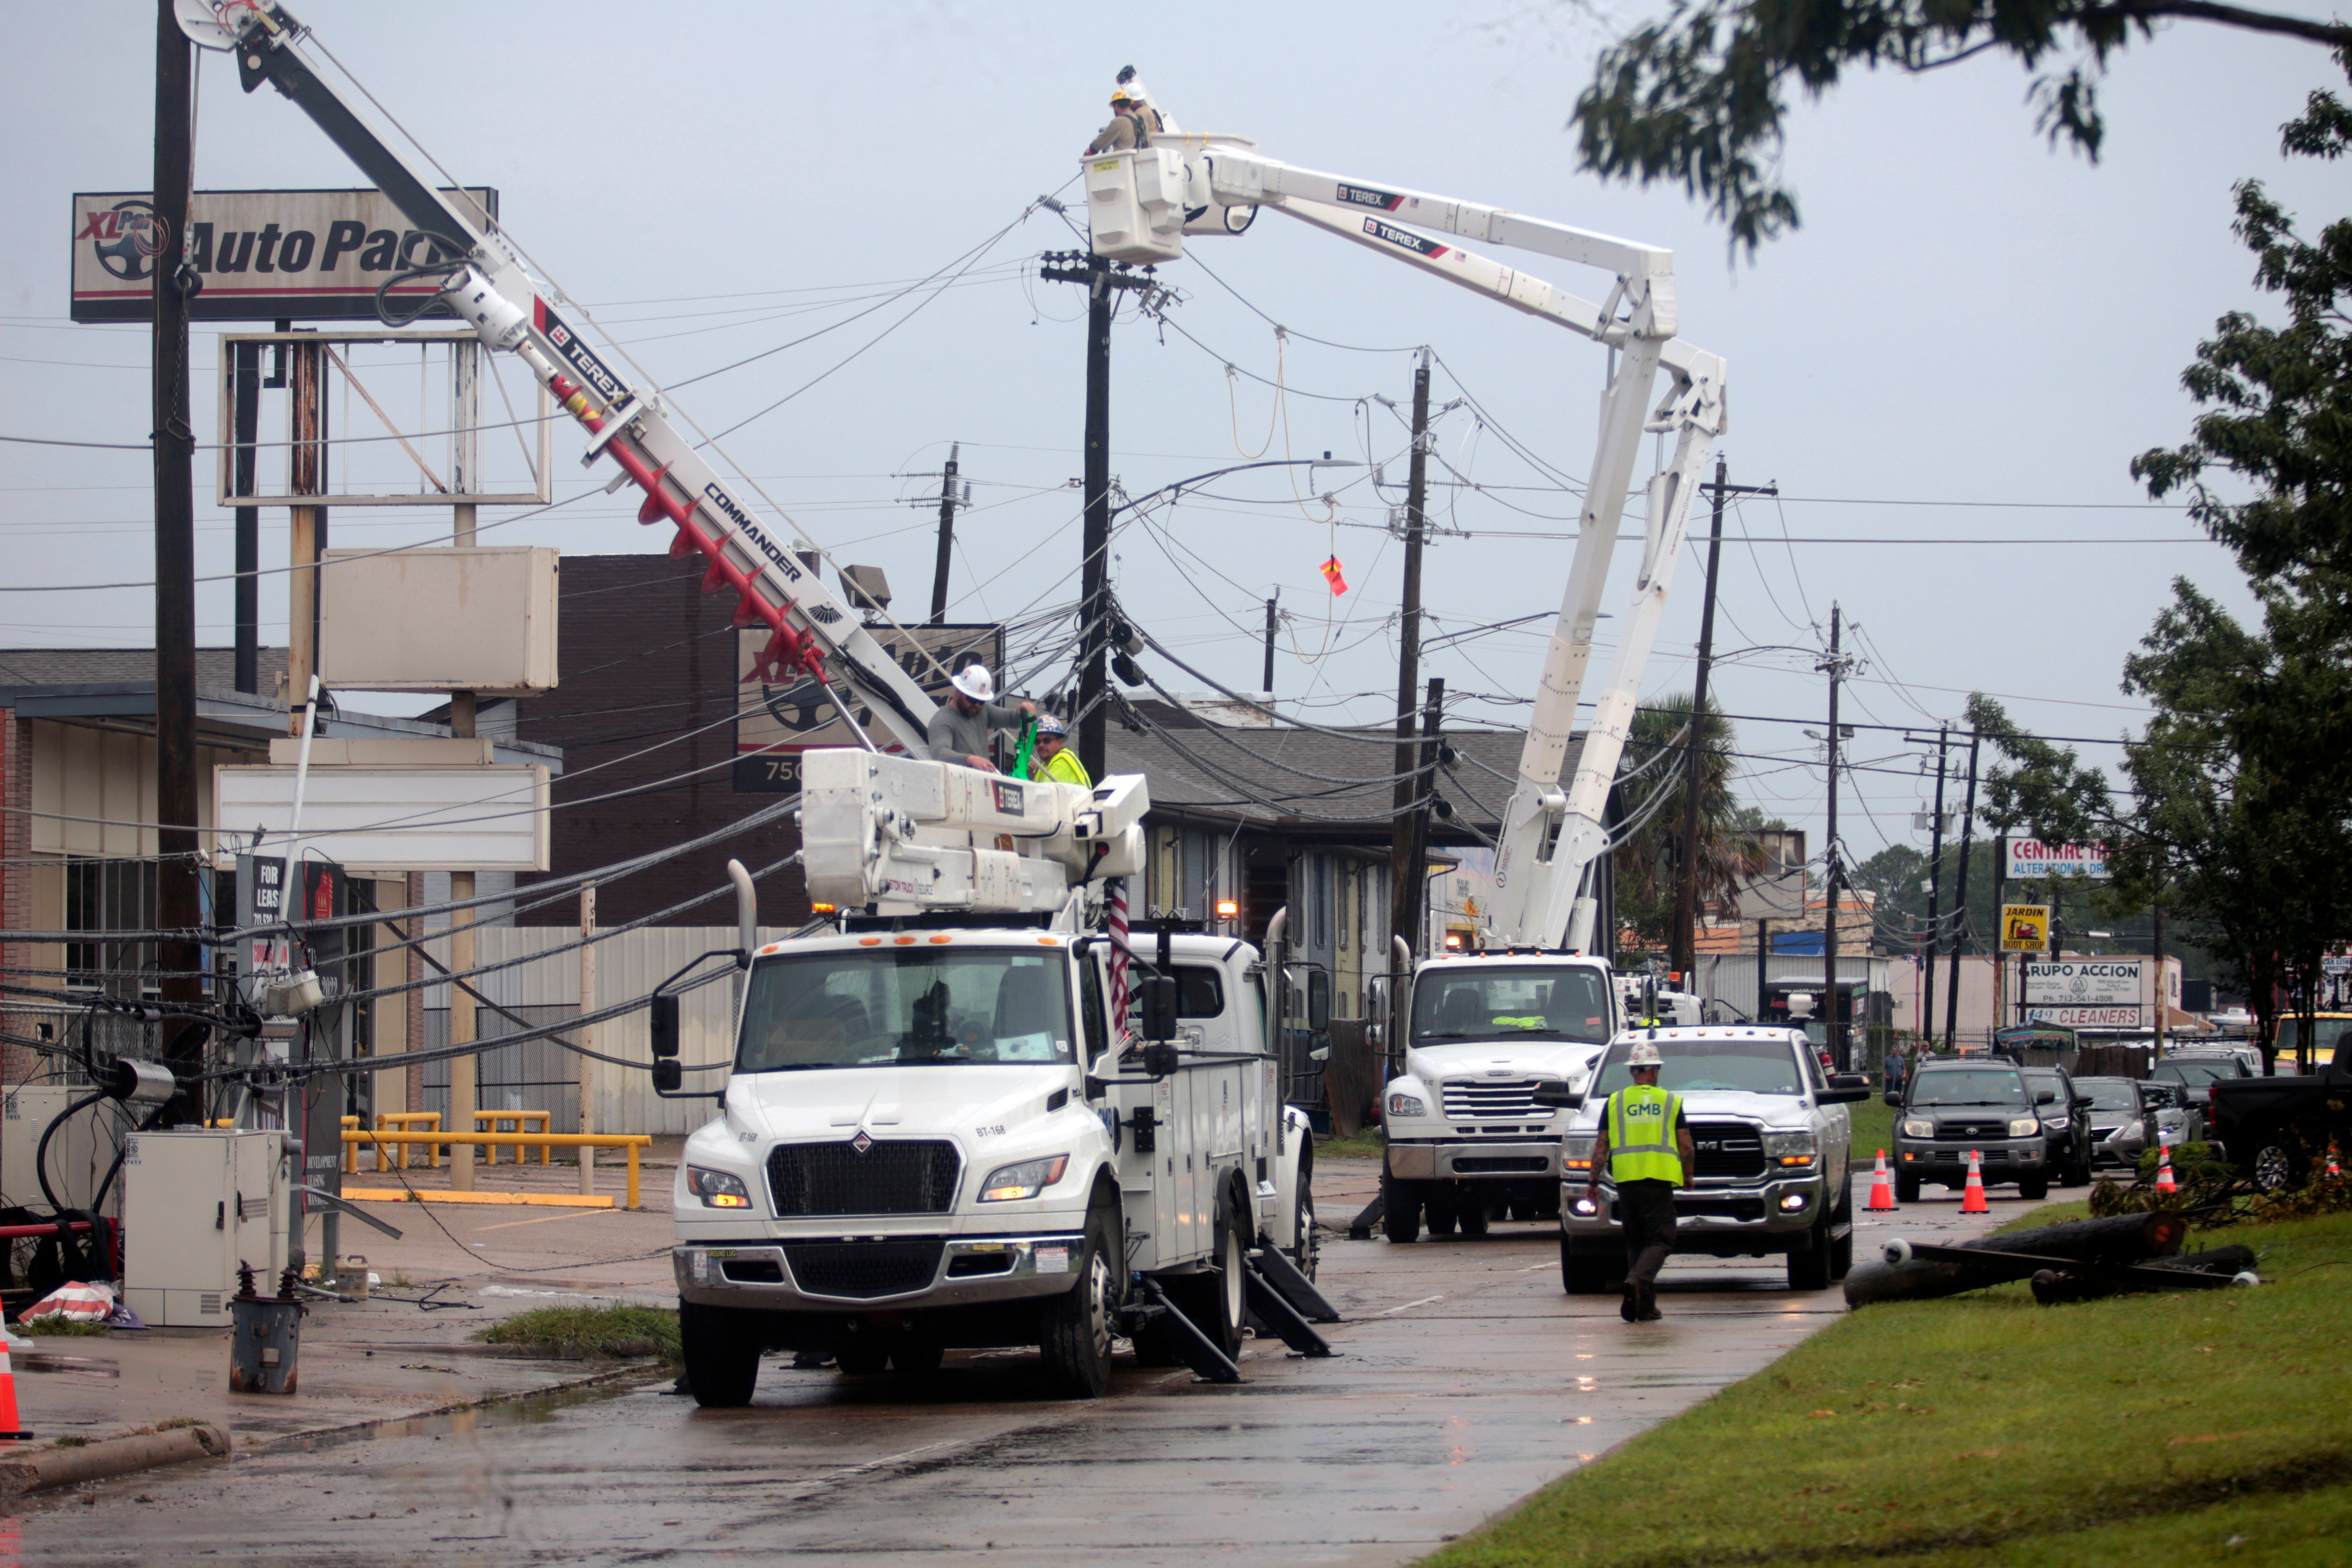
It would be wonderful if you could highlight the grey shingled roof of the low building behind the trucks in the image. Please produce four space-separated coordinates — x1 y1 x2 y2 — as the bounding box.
1108 705 1583 837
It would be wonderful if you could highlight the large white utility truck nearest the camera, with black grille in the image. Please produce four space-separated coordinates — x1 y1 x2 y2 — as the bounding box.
656 922 1329 1406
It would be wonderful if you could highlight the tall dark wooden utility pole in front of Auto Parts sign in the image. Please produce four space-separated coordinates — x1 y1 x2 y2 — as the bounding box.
151 0 207 1121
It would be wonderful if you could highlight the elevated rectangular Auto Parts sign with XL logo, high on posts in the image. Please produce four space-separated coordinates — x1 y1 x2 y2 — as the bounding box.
73 188 499 322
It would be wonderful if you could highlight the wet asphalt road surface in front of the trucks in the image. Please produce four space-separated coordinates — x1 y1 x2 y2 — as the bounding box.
0 1176 2030 1568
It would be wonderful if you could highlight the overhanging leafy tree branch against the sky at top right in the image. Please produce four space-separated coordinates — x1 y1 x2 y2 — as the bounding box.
1576 0 2352 252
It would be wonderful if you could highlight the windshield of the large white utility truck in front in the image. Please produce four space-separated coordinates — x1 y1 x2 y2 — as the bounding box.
736 947 1075 1072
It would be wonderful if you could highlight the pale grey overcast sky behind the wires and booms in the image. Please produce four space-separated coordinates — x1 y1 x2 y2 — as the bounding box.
0 0 2345 860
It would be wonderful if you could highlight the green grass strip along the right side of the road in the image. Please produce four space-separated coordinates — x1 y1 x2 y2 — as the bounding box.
1428 1206 2352 1568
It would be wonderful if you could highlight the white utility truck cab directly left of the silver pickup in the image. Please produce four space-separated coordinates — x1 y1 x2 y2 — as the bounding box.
1381 952 1623 1241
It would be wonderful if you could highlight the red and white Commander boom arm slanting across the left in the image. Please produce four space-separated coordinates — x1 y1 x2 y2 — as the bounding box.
176 0 934 755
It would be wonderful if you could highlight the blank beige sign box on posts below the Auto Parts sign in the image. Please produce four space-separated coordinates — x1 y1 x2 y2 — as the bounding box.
322 546 557 701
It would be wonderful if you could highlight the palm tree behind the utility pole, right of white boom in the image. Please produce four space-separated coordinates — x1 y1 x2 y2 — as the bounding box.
1616 691 1764 947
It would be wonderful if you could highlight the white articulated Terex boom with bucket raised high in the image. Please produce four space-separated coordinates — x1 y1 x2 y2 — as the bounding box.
1087 136 1724 947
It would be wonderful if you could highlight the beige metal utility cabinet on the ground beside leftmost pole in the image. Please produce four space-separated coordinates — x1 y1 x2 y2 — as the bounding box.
122 1128 294 1328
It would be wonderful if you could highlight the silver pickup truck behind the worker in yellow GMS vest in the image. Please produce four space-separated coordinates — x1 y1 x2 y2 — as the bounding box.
1548 1025 1870 1295
